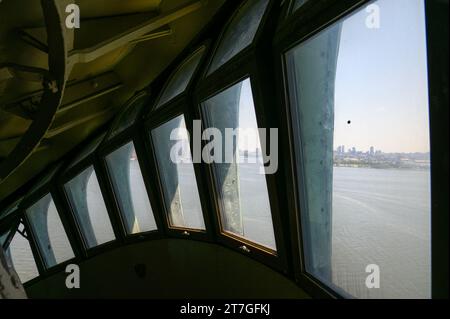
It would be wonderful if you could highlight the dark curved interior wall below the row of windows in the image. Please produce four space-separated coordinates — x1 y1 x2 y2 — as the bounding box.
26 239 309 299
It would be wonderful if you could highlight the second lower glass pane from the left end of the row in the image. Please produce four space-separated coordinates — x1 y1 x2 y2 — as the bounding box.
27 194 75 268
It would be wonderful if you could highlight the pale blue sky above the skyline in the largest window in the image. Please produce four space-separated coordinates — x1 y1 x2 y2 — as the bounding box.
334 0 430 153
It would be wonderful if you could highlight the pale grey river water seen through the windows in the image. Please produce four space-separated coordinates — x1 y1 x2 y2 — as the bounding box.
6 162 431 298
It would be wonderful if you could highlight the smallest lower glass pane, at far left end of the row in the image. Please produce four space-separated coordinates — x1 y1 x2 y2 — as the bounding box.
6 233 39 283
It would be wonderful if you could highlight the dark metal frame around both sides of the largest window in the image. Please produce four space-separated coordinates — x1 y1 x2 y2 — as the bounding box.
274 0 448 299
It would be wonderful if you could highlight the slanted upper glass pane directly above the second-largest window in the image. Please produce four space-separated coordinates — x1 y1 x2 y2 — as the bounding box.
208 0 269 75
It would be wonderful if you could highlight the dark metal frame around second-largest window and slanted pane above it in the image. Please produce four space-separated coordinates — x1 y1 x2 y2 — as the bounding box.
193 1 291 276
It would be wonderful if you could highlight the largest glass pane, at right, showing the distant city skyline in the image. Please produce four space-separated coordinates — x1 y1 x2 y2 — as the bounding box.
286 0 431 298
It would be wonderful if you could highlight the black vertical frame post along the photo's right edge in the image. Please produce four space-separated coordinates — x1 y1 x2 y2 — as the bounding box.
425 0 449 299
